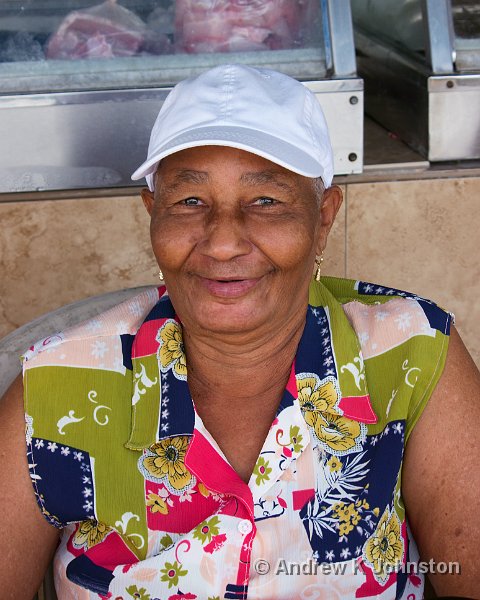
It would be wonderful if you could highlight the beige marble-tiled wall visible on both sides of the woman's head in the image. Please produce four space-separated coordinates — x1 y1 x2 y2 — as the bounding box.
0 177 480 365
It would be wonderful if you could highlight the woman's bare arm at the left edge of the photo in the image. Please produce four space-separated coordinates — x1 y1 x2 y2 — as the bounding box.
0 377 58 600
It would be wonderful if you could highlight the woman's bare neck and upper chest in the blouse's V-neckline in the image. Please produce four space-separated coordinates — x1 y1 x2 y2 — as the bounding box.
184 307 306 483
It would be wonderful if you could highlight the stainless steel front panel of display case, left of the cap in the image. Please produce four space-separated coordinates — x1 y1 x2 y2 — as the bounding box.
0 88 169 192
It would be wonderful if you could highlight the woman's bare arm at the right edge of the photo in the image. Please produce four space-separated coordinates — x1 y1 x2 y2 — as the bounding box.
402 329 480 598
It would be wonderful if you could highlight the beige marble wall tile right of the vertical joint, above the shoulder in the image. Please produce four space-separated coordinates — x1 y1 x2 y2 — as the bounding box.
346 177 480 365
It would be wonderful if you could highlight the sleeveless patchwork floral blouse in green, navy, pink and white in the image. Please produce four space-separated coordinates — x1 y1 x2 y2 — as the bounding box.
24 277 452 600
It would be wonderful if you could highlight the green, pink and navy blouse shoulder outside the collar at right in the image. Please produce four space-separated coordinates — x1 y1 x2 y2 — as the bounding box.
320 277 453 437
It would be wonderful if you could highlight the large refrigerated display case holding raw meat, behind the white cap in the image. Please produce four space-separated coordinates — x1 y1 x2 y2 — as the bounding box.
0 0 363 193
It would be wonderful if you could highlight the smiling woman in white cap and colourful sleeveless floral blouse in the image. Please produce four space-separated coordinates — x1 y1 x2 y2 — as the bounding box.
1 65 480 600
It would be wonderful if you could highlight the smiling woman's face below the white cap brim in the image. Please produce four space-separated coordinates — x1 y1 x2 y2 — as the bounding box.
142 146 340 333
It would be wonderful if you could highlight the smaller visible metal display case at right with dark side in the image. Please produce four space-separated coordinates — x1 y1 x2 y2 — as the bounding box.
351 0 480 162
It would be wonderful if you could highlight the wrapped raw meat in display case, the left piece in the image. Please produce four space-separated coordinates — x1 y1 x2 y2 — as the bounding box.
46 0 146 59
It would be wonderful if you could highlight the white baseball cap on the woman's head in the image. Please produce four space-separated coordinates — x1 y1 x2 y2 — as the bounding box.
132 65 333 191
